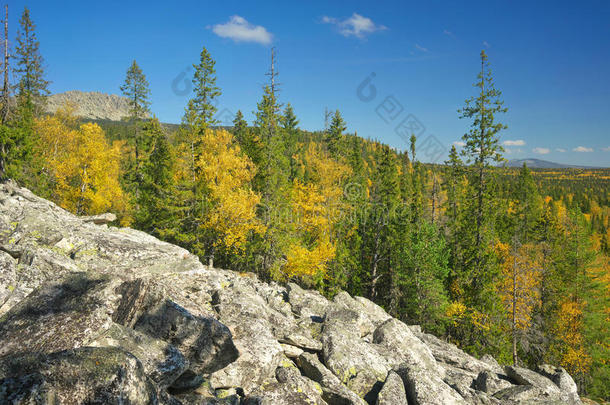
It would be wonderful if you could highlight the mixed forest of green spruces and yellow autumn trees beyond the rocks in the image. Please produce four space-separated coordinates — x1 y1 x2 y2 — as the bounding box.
0 5 610 400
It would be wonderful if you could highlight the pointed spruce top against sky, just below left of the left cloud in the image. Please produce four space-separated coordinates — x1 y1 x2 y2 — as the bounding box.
185 47 221 128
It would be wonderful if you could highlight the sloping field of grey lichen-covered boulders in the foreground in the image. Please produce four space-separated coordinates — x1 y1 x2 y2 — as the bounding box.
0 182 580 405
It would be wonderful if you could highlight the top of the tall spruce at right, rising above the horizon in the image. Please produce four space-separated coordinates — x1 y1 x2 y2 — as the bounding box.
458 51 508 167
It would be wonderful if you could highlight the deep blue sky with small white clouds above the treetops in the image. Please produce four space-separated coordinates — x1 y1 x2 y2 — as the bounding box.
9 0 610 166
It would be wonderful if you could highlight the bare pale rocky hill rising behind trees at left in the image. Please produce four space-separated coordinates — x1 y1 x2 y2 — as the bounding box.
46 90 129 121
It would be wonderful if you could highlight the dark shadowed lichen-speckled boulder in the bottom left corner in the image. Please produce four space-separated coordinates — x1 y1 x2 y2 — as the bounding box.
0 347 160 405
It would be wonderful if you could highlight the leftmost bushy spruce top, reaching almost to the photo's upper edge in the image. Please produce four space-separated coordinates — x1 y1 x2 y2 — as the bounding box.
15 7 49 112
